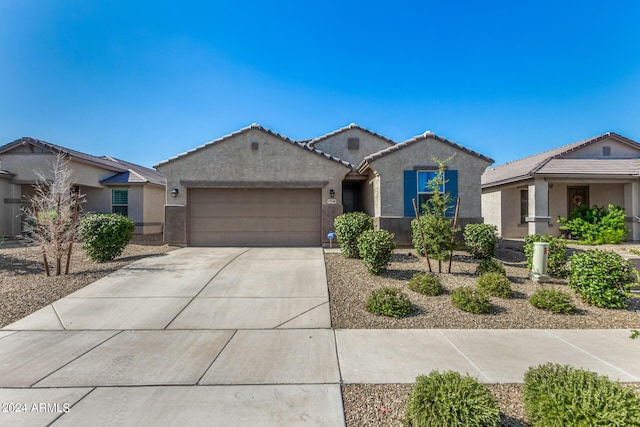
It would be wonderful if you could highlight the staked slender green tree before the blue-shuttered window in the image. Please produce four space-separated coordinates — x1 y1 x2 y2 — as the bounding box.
411 157 460 272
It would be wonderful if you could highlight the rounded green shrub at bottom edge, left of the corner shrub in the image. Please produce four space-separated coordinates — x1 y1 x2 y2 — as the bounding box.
404 371 500 427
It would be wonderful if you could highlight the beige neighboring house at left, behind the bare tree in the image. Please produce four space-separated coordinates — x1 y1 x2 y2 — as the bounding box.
0 138 165 236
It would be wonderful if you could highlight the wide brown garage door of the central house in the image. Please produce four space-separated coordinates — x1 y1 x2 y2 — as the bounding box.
188 188 322 246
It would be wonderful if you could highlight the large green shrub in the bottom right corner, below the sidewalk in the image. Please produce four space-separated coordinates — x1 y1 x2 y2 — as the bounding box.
523 363 640 427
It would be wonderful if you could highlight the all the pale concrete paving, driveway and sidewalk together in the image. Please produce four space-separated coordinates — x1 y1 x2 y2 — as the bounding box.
0 248 640 426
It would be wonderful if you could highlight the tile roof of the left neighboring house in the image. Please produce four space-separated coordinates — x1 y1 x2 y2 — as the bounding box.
0 137 166 185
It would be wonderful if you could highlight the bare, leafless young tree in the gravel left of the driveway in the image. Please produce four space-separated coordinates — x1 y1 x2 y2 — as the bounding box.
23 154 83 276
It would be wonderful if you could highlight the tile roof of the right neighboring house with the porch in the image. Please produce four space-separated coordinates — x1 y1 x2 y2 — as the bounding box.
482 132 640 188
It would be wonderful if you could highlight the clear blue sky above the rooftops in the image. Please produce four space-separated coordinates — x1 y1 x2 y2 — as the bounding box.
0 0 640 166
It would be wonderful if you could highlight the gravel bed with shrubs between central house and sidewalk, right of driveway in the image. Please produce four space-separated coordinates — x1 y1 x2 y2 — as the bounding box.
325 242 640 329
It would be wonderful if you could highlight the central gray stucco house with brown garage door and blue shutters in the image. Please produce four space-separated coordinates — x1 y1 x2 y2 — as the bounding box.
155 124 493 246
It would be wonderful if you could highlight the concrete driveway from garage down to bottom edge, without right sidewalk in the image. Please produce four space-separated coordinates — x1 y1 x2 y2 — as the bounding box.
0 248 344 426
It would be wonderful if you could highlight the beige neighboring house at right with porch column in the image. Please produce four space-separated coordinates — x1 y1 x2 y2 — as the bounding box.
482 132 640 240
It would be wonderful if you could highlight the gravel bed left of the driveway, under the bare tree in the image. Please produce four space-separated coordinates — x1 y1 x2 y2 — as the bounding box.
0 236 175 327
